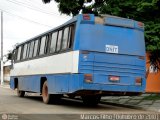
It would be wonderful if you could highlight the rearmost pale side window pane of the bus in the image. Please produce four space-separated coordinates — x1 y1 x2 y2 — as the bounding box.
62 27 69 50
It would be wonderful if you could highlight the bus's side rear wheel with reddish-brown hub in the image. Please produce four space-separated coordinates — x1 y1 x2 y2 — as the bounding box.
42 81 61 104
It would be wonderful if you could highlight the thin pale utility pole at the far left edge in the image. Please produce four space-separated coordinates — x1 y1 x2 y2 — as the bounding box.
1 11 4 85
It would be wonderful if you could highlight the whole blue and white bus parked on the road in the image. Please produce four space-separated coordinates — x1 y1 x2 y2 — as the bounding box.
10 14 146 104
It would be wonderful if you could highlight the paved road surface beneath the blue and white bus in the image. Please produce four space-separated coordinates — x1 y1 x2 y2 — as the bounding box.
0 86 158 120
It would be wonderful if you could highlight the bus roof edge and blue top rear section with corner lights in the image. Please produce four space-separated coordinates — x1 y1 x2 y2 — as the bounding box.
16 14 144 47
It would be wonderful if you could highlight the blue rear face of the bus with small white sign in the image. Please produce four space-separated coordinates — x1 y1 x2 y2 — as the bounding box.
74 15 146 92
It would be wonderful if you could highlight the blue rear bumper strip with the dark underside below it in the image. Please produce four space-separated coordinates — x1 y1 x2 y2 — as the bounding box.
72 84 144 96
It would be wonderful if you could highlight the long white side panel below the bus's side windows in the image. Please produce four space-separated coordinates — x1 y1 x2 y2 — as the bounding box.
11 51 79 76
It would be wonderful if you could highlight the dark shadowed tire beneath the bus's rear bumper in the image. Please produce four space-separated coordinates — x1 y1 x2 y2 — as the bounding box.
81 95 101 106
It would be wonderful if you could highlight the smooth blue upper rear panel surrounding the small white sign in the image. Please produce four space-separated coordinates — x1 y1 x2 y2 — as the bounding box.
77 24 145 56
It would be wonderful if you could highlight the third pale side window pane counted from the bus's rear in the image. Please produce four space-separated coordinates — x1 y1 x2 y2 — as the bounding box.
50 32 57 53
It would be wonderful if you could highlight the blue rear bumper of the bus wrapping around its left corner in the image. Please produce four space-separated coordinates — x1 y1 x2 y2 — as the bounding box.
70 74 146 94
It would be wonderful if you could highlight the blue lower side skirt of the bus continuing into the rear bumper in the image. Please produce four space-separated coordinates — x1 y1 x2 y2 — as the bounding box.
11 74 145 94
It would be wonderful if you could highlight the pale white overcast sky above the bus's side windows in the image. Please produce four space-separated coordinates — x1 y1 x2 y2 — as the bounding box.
0 0 71 55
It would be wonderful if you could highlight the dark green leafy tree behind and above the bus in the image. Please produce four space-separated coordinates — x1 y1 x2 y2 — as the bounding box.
42 0 160 68
